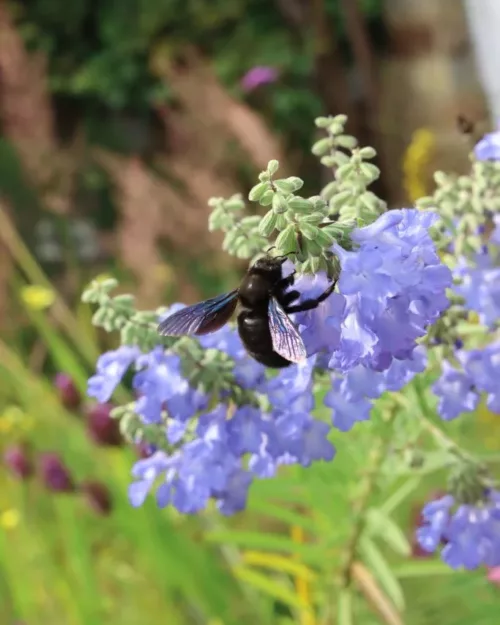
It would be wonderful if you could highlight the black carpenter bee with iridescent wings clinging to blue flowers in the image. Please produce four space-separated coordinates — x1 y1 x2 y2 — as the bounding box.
158 256 336 369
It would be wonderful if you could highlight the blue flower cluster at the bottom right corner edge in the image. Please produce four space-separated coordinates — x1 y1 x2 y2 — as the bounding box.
416 490 500 570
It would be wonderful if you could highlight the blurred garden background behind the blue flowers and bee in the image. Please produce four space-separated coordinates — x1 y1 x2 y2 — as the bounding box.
0 0 500 625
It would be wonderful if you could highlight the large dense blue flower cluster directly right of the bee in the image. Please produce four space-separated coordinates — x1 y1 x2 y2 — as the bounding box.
296 209 452 373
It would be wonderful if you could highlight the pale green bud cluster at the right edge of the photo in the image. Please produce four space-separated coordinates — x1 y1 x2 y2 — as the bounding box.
417 160 500 257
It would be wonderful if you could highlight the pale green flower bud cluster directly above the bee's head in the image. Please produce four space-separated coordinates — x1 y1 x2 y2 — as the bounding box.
209 115 387 274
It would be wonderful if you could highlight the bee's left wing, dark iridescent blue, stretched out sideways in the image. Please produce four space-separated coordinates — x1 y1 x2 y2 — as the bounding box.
158 289 238 336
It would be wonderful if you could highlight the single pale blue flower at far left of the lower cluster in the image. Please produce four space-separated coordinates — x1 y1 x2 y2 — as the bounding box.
87 345 141 404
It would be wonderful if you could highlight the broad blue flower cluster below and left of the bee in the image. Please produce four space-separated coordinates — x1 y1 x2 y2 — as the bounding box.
89 344 335 514
